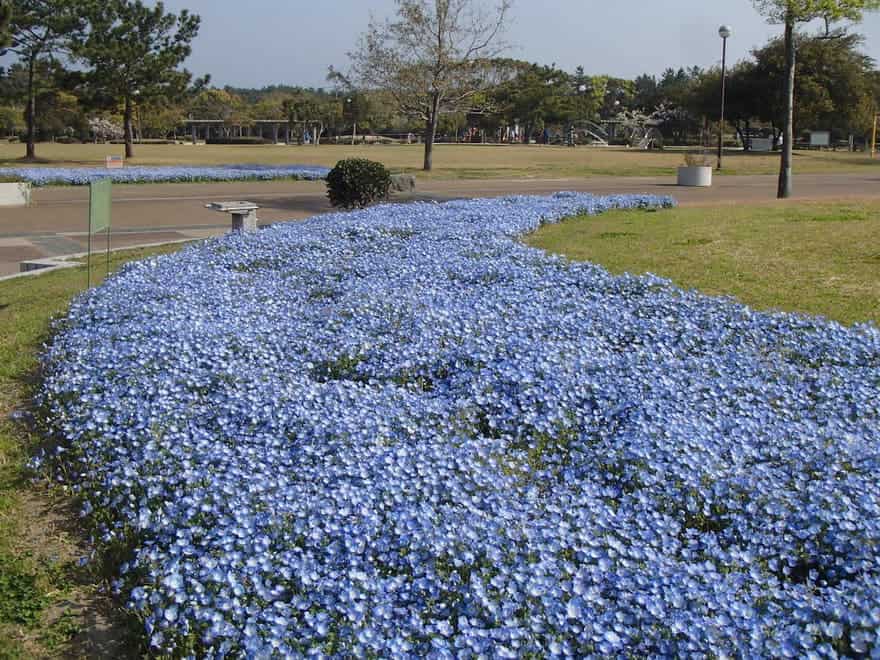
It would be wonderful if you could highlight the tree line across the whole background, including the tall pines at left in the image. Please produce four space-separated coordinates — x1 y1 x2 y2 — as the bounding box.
0 0 880 158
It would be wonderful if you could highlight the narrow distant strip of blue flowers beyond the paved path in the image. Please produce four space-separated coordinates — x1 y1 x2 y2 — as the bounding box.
0 165 330 186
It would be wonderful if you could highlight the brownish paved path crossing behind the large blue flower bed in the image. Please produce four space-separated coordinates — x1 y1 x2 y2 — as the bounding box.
0 174 880 276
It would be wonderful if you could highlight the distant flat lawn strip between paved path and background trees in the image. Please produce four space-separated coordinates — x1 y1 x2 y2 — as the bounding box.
0 142 880 179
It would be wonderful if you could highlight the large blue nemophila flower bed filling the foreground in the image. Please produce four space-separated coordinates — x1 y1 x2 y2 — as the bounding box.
42 194 880 658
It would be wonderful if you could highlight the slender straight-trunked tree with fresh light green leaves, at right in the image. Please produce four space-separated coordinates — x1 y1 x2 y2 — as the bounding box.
752 0 880 198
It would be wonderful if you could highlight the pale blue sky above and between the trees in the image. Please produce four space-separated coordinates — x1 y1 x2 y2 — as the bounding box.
155 0 880 87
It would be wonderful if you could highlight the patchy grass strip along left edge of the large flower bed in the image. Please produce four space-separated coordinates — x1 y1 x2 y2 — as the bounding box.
0 245 180 660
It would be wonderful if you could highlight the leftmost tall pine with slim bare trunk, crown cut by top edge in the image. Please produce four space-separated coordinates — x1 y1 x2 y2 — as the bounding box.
8 0 85 160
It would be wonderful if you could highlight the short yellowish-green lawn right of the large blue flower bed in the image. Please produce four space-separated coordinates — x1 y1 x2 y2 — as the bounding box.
528 202 880 324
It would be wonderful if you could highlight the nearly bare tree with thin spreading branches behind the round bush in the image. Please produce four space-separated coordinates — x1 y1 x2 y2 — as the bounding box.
349 0 512 170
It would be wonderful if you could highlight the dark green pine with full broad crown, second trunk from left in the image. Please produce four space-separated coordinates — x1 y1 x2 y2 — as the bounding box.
76 0 200 158
